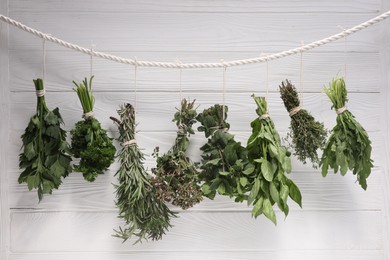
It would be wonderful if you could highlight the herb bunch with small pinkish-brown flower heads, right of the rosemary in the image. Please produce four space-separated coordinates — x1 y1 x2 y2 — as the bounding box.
152 99 202 209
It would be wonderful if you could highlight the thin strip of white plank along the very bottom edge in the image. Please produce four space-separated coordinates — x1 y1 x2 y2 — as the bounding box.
10 250 383 260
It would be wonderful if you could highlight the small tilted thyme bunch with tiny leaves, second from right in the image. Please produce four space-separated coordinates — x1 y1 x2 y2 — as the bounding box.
279 80 327 168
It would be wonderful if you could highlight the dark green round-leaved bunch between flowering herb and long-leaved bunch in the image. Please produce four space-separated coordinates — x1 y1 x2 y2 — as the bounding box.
196 104 248 202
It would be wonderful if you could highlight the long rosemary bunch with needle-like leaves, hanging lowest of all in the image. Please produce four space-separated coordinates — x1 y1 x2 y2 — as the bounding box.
110 104 175 243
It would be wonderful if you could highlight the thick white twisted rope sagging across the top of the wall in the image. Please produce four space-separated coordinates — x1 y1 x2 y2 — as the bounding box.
0 10 390 69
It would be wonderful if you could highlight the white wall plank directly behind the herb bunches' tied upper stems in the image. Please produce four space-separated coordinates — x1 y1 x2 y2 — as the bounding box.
9 91 381 133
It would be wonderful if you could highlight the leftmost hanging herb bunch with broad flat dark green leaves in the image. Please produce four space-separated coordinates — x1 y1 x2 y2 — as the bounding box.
18 79 72 201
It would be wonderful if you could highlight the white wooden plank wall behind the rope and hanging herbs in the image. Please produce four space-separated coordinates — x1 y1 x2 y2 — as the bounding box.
0 0 390 260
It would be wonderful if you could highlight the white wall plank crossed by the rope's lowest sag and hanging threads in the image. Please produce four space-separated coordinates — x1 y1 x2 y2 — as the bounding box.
10 49 381 93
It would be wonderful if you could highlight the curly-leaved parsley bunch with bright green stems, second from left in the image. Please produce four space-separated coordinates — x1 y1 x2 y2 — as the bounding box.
70 76 116 182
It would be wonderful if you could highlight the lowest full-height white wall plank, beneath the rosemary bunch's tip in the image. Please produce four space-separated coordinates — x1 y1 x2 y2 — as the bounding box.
11 211 382 253
